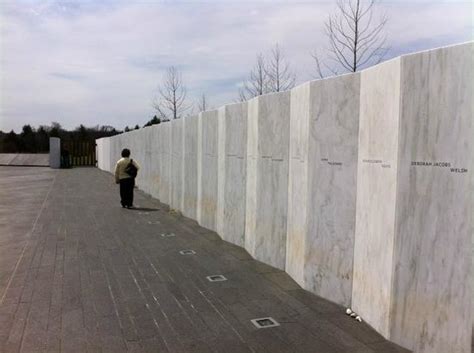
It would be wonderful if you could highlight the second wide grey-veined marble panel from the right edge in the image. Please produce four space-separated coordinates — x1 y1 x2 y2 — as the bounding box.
304 74 360 306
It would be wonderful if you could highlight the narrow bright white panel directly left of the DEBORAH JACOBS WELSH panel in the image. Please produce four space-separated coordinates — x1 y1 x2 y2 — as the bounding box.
352 58 400 338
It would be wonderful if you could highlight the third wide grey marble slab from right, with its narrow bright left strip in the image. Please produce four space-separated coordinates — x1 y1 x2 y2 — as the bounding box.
245 92 290 270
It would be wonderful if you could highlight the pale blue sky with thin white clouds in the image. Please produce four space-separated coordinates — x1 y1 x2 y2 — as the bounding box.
0 0 474 132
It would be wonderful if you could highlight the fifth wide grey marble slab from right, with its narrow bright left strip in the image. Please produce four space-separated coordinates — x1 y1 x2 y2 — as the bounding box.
197 110 218 231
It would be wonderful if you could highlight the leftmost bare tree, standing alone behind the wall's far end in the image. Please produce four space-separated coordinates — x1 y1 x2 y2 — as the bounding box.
153 66 190 121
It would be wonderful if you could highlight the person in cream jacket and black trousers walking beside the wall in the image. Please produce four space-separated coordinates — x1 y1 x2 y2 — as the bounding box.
115 148 140 208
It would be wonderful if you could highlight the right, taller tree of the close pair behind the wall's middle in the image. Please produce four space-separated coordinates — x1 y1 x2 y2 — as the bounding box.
265 44 296 92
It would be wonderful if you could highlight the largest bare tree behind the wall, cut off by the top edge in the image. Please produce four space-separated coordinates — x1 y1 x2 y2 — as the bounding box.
312 0 388 78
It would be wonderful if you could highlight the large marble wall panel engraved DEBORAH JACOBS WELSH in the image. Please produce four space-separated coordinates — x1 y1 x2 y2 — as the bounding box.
390 43 474 353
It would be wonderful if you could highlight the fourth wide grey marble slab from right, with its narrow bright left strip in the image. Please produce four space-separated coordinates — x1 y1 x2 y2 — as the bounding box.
216 102 247 247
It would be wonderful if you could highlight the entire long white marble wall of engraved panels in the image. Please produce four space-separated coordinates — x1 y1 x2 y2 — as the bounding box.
97 43 474 353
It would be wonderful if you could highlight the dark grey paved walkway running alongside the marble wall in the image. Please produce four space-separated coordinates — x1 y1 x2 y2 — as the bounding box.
0 167 407 353
